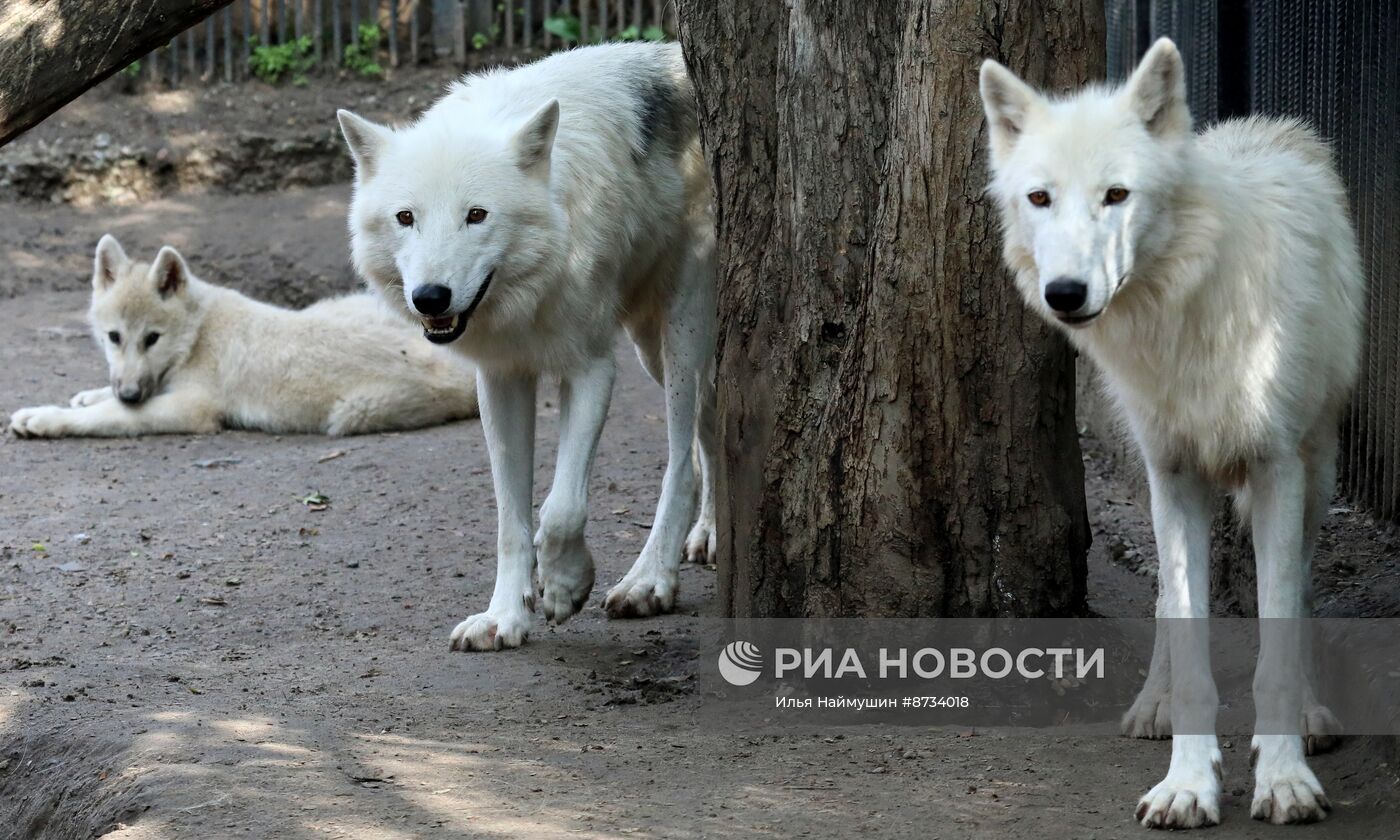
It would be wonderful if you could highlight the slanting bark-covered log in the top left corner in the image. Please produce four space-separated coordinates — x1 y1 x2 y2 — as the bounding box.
0 0 232 146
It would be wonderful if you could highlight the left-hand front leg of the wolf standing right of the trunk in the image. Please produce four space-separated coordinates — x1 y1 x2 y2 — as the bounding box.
1137 456 1221 829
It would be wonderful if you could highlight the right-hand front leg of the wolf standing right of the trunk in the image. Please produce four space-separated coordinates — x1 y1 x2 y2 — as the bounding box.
1249 451 1331 823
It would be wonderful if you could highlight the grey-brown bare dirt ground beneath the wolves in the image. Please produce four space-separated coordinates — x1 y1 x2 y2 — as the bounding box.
0 86 1400 840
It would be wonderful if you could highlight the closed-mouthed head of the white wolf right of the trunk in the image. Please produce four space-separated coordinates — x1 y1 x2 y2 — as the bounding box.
981 38 1191 328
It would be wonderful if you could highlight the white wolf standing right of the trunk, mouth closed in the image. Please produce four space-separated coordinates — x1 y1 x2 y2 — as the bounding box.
981 39 1365 827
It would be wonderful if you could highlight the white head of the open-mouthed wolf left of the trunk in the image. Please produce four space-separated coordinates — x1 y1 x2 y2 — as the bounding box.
337 102 566 344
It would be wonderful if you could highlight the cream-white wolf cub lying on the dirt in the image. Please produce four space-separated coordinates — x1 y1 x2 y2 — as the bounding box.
10 235 476 437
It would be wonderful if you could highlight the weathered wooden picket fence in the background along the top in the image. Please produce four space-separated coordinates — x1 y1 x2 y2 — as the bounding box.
140 0 675 85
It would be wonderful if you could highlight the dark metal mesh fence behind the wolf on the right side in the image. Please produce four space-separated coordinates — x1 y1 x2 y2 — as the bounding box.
1107 0 1400 519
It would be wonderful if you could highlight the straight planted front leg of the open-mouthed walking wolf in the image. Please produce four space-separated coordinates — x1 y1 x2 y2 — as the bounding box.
452 370 536 651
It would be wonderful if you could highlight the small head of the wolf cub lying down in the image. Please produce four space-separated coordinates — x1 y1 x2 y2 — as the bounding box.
88 234 199 406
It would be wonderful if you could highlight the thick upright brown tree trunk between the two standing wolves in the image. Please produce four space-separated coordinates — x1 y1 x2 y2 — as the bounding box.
679 0 1105 616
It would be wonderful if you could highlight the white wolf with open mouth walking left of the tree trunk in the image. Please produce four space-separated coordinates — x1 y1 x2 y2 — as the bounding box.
339 45 715 650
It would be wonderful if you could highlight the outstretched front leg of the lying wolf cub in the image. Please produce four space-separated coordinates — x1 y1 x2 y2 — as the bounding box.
10 391 220 437
